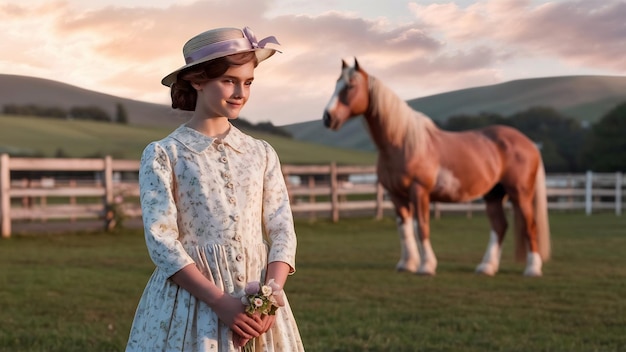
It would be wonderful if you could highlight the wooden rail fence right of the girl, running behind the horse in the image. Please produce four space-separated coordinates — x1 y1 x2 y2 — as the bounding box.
283 164 625 221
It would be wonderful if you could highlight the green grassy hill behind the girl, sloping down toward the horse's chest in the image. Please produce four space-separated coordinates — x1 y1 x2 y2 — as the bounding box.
0 74 375 165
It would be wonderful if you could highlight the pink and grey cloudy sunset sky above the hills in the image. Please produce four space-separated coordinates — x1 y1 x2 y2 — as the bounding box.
0 0 626 125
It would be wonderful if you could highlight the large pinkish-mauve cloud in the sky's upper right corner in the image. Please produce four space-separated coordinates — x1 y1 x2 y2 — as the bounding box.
411 0 626 72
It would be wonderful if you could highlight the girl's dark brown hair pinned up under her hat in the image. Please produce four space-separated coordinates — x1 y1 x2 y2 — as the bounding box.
170 52 259 111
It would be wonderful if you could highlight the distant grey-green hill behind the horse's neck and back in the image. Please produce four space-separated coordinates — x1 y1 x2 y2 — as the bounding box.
282 76 626 150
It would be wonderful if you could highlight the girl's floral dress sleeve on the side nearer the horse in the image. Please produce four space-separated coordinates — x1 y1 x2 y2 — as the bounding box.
263 141 297 273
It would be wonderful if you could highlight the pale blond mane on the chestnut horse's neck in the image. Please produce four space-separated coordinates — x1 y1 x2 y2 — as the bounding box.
368 76 436 154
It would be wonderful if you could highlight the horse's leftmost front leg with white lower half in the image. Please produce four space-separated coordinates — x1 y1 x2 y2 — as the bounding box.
391 196 420 273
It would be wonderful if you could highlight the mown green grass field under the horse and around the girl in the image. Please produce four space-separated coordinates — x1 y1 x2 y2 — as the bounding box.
0 213 626 352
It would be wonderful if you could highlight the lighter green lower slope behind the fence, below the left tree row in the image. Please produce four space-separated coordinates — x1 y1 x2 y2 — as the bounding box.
0 115 376 165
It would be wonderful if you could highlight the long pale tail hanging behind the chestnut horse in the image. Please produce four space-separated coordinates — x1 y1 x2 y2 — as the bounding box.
535 160 551 262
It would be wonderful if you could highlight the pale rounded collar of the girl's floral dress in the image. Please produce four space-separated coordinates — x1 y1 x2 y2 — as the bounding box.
171 124 246 153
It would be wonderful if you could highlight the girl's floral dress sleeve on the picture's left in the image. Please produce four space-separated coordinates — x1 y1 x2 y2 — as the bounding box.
139 142 194 277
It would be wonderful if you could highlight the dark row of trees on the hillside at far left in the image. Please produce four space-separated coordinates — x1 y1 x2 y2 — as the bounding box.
2 103 128 125
